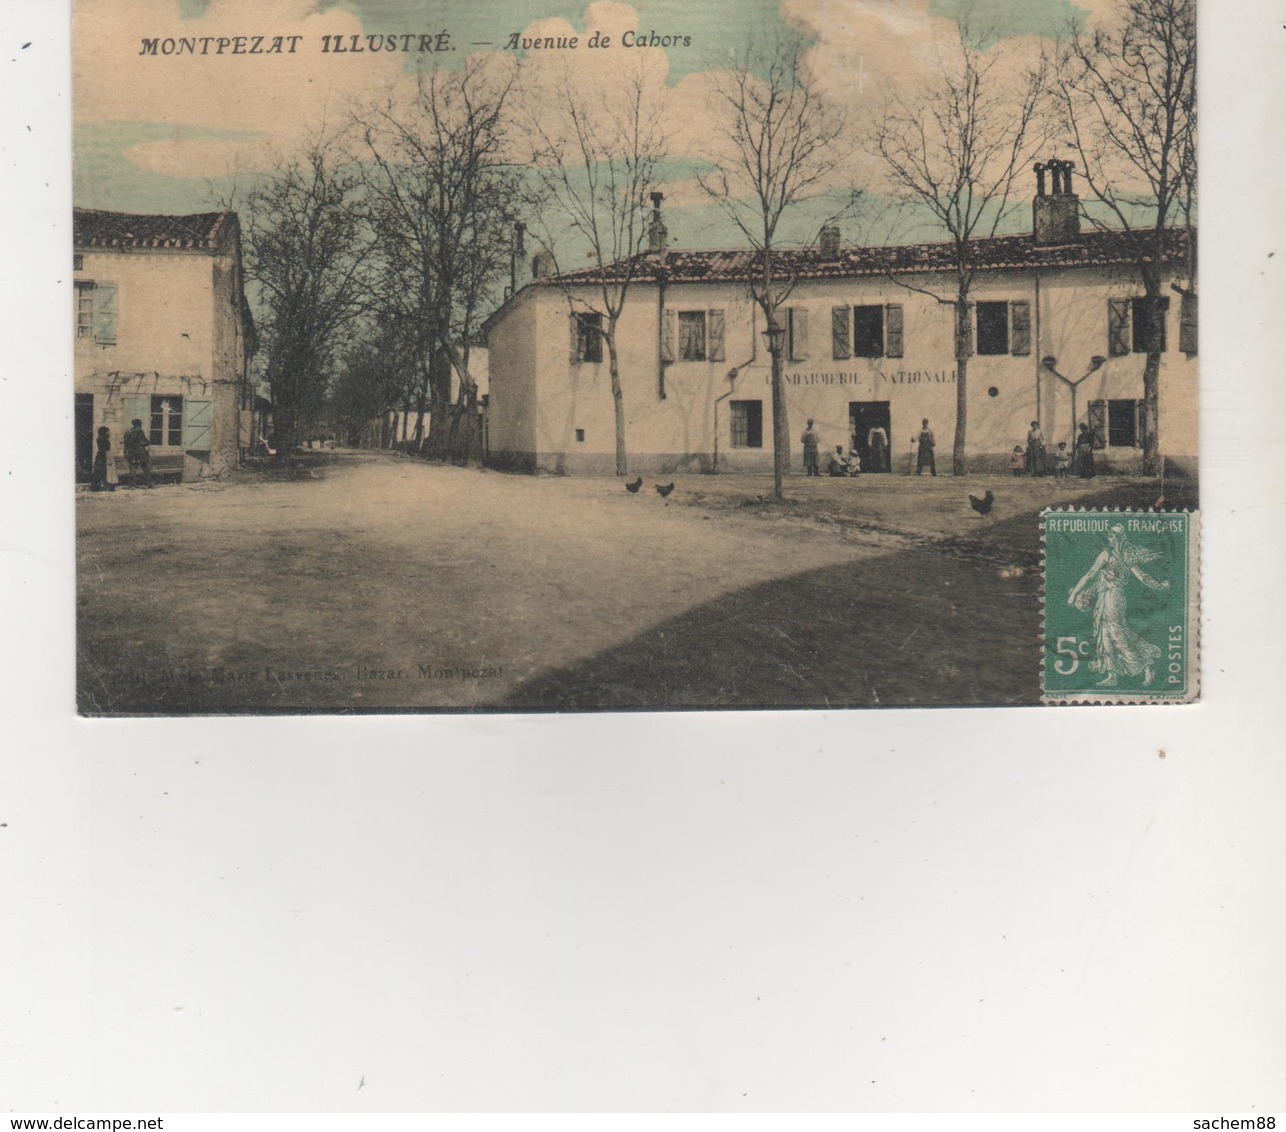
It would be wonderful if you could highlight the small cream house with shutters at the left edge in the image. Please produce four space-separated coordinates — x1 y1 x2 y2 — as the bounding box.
73 208 255 480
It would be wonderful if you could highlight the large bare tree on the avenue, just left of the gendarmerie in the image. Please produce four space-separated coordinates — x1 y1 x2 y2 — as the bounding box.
358 58 517 463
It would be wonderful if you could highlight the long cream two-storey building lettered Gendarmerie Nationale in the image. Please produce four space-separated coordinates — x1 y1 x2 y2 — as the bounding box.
486 176 1197 475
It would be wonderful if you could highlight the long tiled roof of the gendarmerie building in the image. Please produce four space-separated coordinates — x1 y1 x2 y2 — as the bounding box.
545 228 1188 286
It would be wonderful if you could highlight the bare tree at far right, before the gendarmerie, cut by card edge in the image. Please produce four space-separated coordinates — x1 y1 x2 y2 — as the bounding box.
1056 0 1197 475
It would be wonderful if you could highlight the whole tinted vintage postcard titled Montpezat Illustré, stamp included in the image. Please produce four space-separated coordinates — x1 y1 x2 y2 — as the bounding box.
68 0 1200 715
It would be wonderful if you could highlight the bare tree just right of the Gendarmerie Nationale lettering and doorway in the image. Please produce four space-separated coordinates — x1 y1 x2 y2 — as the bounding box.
871 17 1044 476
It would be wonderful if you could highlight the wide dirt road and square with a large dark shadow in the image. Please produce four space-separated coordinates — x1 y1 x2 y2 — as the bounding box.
77 454 1183 714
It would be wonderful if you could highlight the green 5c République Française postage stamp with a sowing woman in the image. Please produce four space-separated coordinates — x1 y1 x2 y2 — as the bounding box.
1040 511 1200 704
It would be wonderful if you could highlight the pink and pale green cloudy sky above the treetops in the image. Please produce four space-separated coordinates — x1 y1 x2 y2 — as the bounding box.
73 0 1110 246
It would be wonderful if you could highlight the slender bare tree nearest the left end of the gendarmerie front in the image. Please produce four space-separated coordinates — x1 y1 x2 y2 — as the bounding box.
530 59 667 476
